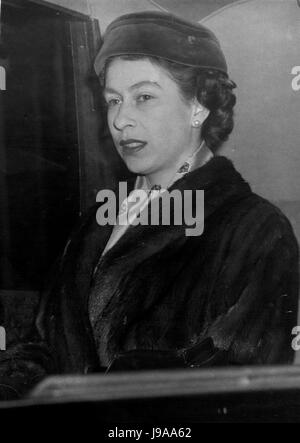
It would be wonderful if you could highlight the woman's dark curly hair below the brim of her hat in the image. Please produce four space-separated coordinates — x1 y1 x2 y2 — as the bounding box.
100 55 236 152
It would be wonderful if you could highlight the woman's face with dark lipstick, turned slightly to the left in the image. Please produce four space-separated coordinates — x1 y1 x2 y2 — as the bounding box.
104 58 203 184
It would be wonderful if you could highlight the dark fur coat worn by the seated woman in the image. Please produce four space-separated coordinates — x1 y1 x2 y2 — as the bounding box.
1 157 298 396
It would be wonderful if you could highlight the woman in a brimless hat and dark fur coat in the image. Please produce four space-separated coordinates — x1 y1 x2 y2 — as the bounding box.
1 12 298 398
